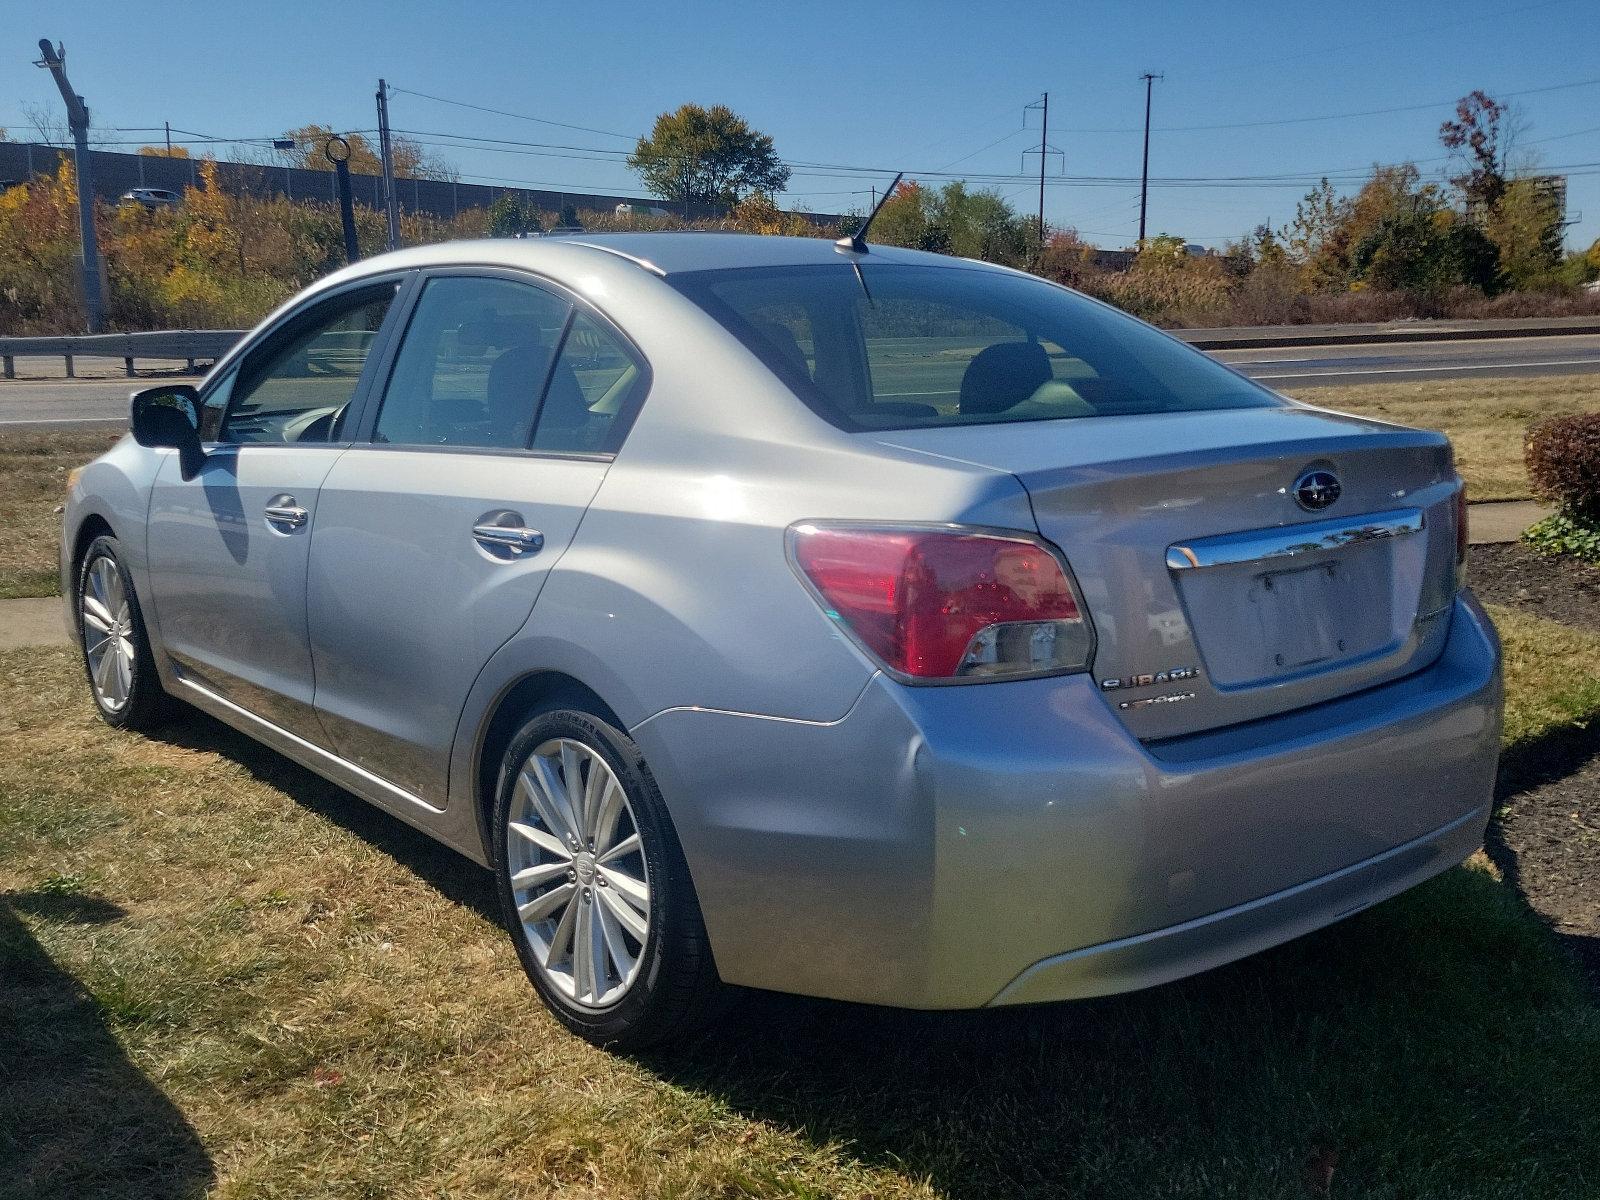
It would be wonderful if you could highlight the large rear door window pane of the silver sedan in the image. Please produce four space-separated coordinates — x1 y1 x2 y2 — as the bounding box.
373 275 571 450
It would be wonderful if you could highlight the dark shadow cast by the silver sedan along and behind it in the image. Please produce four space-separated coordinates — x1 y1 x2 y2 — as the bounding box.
147 700 1600 1200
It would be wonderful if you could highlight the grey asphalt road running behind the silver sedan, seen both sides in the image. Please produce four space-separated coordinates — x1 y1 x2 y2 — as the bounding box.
0 334 1600 429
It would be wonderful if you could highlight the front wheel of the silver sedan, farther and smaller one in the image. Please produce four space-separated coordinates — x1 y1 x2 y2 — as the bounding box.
74 534 171 733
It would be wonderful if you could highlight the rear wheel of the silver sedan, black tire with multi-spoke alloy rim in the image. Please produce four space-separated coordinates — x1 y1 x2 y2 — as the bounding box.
493 704 730 1051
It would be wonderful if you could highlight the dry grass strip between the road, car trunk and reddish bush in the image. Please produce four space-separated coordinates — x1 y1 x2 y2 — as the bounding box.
1293 374 1600 501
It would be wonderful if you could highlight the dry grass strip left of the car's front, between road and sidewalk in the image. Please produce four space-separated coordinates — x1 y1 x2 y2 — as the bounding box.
0 432 118 600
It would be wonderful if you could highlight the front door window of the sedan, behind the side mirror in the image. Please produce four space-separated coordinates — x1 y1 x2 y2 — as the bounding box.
219 283 397 442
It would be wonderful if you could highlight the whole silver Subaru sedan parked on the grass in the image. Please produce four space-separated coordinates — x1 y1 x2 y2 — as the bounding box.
61 234 1501 1048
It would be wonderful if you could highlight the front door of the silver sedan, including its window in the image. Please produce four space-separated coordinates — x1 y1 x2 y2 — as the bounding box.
147 282 395 746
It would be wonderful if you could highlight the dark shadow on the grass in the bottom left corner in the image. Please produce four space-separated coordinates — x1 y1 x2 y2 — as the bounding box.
0 893 216 1200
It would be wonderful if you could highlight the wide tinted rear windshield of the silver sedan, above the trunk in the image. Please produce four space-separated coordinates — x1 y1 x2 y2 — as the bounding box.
669 259 1283 429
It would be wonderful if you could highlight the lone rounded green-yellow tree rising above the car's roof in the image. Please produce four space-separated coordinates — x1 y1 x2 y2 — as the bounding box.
627 104 789 205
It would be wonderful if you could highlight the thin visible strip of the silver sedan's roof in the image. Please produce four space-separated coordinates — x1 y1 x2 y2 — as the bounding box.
341 232 979 275
